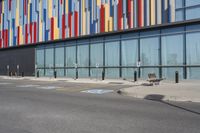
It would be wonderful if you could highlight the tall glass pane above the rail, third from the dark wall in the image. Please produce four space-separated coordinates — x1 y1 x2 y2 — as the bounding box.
55 47 64 67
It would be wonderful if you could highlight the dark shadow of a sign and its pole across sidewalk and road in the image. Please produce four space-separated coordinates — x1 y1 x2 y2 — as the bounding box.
144 94 200 115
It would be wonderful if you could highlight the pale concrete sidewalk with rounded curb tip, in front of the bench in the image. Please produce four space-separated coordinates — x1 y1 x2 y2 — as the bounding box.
120 80 200 102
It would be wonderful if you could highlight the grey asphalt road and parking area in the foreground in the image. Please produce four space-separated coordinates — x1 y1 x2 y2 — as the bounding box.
0 79 200 133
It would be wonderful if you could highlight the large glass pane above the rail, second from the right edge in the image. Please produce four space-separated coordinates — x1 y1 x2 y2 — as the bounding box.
162 34 183 65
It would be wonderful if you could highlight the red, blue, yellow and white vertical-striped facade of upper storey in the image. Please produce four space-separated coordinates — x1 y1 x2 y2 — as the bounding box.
0 0 175 48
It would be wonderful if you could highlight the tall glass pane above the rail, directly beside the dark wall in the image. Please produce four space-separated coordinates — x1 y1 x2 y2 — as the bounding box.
36 49 44 68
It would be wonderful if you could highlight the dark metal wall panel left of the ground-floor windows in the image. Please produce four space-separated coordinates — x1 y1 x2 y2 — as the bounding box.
0 47 35 76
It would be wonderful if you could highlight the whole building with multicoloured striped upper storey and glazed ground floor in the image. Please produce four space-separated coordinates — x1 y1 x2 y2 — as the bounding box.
0 0 200 79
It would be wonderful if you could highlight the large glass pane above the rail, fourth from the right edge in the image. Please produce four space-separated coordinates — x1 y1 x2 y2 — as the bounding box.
121 39 138 66
